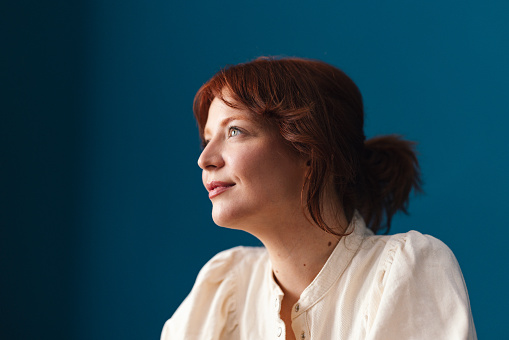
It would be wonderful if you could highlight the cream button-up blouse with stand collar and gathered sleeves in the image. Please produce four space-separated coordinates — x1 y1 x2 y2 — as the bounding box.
161 214 477 340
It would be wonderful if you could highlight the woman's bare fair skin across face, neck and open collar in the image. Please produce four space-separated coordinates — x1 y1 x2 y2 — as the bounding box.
198 98 348 339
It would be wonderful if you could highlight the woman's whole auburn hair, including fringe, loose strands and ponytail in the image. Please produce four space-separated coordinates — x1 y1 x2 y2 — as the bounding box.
193 58 421 234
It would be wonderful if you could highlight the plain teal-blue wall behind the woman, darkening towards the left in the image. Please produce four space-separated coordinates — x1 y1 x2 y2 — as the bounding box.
0 0 509 340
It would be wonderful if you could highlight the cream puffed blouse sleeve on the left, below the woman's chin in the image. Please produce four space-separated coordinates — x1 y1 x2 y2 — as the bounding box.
161 249 240 340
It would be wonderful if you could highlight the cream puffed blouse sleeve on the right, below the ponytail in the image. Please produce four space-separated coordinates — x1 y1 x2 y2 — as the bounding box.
367 231 477 340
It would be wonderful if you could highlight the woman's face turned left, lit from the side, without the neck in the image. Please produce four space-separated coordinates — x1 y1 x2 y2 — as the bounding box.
198 98 308 234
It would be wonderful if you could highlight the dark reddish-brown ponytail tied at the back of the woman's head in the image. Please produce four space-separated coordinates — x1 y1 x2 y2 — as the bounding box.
358 135 422 233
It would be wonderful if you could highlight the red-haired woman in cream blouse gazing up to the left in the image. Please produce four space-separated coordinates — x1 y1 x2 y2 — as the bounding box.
161 58 476 340
